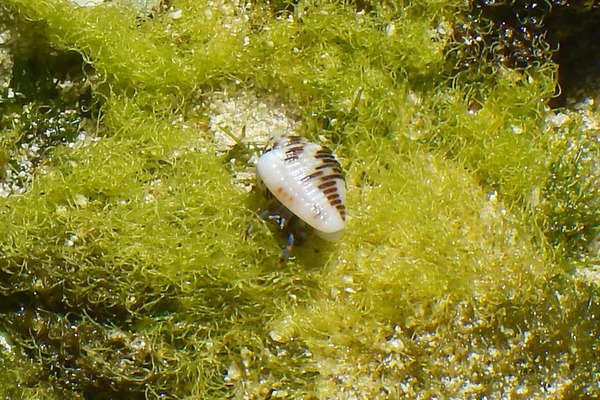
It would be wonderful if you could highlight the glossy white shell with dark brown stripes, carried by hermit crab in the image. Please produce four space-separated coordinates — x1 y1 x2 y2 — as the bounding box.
256 136 346 241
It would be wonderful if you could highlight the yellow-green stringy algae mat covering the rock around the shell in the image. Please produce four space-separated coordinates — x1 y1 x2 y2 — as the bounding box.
0 0 600 399
